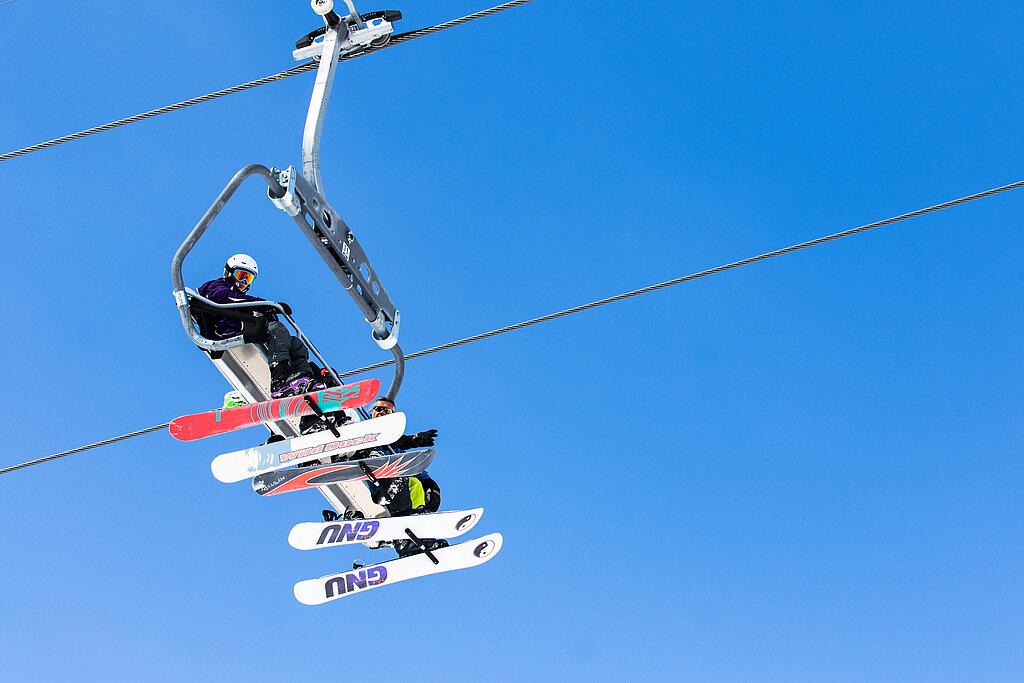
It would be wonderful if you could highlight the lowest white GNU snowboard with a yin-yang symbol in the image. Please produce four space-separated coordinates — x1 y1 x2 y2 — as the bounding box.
295 533 502 605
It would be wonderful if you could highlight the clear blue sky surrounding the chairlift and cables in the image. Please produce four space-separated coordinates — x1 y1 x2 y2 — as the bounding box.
0 0 1024 681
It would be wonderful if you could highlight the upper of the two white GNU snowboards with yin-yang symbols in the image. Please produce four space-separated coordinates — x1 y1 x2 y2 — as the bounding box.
288 508 483 550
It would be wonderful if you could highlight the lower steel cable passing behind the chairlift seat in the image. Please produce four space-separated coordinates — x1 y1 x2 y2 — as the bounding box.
0 180 1024 474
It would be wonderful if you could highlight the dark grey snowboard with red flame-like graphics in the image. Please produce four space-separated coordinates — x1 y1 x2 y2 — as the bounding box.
253 449 434 496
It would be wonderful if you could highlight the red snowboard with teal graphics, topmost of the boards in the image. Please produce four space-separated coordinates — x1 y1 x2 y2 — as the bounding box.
171 380 381 441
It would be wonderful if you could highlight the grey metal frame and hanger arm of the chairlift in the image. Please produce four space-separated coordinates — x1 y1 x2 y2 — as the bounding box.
171 0 406 517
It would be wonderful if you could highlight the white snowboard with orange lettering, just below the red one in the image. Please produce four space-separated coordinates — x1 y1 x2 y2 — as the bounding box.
210 413 406 483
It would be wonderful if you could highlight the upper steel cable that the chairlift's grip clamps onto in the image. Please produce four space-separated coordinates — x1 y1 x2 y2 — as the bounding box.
0 0 534 161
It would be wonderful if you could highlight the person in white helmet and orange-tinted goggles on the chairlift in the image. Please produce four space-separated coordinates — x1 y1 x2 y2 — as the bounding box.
198 254 327 398
